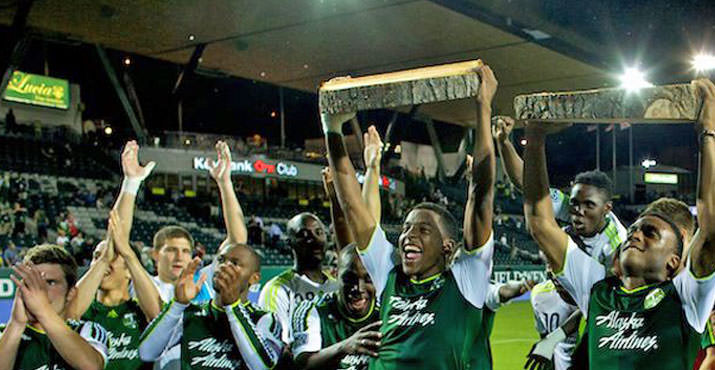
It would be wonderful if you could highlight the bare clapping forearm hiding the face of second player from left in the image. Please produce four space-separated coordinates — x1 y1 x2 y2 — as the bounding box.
109 210 162 321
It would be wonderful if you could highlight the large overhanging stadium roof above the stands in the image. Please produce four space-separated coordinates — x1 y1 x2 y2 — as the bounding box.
0 0 611 124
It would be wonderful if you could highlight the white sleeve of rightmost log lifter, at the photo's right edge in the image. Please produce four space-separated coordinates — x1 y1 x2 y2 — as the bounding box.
673 257 715 333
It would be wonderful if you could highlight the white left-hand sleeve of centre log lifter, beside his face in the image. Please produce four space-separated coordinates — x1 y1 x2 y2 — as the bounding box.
358 225 395 297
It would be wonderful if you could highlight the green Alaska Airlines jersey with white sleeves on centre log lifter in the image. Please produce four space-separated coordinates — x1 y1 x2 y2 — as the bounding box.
360 227 493 370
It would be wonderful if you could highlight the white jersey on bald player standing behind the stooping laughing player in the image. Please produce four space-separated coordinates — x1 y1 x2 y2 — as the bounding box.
258 269 338 344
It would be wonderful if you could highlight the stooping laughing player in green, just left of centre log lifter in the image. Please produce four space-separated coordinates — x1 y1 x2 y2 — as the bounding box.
292 244 381 370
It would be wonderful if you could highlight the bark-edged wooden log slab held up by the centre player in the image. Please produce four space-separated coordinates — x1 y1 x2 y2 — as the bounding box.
318 60 483 114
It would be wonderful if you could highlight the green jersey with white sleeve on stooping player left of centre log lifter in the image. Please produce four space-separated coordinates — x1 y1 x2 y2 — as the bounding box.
292 293 380 370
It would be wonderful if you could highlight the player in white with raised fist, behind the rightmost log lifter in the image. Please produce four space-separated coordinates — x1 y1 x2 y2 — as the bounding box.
492 116 626 267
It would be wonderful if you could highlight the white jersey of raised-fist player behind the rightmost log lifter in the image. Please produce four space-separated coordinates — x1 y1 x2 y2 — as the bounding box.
549 188 628 268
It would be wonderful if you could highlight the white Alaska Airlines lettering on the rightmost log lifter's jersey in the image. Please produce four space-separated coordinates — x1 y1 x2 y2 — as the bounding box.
596 311 658 352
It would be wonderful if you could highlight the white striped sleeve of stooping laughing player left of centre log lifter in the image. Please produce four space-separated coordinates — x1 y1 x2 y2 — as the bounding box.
291 301 323 358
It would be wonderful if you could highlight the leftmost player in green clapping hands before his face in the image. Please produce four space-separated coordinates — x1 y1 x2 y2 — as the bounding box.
0 244 107 370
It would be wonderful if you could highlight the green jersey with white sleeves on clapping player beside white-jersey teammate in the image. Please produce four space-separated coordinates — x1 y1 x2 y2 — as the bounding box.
139 301 283 370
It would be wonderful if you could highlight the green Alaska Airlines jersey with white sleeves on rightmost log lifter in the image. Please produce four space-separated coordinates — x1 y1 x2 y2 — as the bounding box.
559 240 715 370
